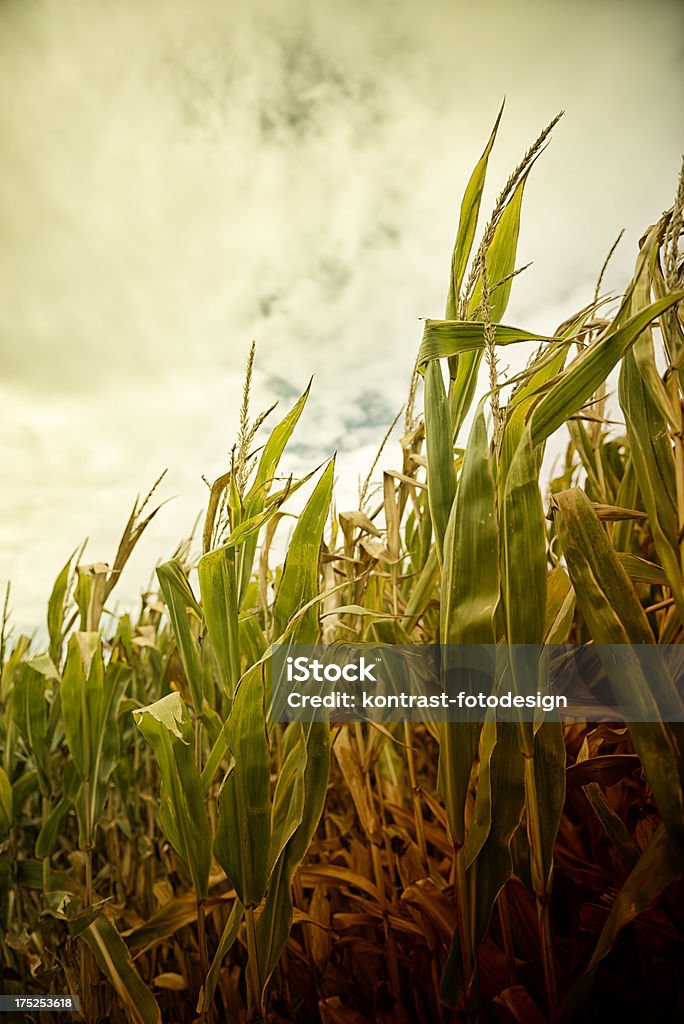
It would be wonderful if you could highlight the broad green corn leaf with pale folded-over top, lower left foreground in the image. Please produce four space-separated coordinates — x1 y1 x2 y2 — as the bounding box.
133 692 211 899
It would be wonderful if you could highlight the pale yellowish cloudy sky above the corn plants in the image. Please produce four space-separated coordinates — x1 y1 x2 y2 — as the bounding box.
0 0 684 632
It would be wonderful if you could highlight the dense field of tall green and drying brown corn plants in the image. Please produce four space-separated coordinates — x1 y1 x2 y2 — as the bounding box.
0 108 684 1024
